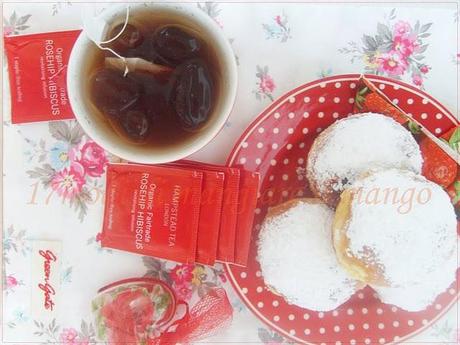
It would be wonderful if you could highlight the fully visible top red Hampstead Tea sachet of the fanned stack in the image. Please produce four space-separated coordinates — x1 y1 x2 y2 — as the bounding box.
101 164 203 263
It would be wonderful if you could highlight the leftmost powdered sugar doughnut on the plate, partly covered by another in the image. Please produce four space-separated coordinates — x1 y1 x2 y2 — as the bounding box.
257 199 360 311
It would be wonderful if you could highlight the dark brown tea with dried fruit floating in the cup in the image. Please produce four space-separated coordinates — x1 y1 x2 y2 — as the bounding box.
89 13 220 147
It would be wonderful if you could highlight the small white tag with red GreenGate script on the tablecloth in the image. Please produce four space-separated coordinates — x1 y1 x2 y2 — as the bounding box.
30 241 62 323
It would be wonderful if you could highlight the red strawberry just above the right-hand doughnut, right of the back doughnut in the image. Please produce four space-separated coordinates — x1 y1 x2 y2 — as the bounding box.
420 137 458 188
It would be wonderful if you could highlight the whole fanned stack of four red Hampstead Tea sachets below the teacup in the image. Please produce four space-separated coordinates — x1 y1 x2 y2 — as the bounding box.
101 161 259 266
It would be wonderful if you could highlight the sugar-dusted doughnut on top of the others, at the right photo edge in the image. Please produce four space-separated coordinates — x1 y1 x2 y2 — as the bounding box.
333 169 457 290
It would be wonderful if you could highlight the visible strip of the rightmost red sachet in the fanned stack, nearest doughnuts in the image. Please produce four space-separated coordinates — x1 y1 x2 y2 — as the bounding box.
234 170 260 266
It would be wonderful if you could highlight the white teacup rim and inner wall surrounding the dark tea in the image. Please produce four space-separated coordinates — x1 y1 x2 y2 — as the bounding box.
67 3 237 164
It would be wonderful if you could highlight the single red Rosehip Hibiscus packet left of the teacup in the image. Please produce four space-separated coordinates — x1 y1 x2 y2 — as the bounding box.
4 30 81 123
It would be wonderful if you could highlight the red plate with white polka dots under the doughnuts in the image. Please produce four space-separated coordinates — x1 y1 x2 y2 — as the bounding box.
226 75 459 345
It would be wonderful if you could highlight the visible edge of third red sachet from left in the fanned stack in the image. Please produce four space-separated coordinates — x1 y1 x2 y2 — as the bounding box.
173 160 240 262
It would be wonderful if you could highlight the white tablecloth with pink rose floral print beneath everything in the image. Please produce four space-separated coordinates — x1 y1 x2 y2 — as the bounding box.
2 2 460 344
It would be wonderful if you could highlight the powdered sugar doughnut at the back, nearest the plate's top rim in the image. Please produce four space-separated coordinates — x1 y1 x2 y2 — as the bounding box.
307 113 423 207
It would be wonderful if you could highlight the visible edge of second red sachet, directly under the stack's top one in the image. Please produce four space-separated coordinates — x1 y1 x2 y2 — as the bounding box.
160 162 225 266
